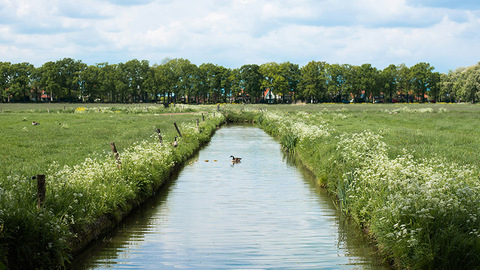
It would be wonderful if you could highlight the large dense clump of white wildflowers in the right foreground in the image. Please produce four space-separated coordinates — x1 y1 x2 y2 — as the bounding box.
337 131 480 268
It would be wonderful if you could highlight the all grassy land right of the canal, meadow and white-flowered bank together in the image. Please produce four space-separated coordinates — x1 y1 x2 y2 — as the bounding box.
244 105 480 269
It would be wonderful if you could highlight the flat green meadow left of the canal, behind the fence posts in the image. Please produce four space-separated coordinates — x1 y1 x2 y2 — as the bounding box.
0 104 206 176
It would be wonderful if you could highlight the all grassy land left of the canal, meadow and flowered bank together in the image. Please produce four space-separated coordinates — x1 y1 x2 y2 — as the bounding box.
0 104 224 269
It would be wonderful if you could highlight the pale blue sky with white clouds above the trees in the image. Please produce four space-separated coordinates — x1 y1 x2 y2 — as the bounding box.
0 0 480 73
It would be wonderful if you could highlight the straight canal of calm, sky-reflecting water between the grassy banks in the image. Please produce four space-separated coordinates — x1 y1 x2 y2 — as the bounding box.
73 126 386 269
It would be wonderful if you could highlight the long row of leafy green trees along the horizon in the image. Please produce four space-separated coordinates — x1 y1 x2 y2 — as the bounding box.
0 58 480 103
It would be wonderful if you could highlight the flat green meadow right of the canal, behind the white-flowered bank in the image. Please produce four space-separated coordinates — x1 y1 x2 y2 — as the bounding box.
246 104 480 164
